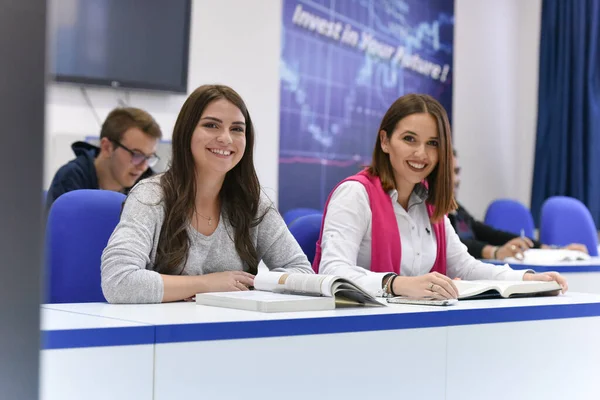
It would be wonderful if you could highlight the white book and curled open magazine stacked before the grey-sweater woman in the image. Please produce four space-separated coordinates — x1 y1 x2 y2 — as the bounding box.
196 271 385 312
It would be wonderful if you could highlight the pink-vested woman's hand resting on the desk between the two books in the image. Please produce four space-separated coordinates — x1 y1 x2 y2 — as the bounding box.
394 272 458 299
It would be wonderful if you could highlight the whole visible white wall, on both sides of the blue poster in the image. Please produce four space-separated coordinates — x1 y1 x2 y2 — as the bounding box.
45 0 541 217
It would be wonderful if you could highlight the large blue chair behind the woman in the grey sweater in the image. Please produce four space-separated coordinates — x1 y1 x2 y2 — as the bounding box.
46 190 125 303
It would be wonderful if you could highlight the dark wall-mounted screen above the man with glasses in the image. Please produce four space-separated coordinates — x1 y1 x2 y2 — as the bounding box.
48 0 191 93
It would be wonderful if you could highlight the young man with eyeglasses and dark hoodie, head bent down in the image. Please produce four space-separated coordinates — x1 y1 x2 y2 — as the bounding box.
46 107 162 208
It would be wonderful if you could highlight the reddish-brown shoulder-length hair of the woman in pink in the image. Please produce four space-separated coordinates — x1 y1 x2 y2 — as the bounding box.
369 94 457 222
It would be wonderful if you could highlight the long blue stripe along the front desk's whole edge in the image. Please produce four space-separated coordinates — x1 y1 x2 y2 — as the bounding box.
42 299 600 350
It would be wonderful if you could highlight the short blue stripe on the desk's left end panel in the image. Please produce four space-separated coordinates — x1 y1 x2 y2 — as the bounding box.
41 326 155 350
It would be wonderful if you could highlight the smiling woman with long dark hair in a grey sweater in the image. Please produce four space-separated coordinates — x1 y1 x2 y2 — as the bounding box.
102 85 312 303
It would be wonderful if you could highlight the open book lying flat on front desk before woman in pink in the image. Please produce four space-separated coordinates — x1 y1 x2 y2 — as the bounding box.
454 280 561 300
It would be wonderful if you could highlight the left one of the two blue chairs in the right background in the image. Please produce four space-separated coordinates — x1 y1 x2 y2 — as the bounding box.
484 199 535 239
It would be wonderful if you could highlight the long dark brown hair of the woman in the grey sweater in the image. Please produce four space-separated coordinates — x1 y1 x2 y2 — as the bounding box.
154 85 260 275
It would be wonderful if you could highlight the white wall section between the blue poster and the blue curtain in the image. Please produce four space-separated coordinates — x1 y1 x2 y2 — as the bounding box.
453 0 541 218
